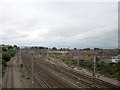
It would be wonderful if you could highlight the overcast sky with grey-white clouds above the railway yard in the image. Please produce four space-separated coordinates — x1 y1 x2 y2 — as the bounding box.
0 0 118 48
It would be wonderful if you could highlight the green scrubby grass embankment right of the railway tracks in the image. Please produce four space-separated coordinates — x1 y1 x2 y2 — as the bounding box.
52 55 120 81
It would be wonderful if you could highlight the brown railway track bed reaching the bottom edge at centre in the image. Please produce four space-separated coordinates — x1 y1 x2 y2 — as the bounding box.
31 57 75 88
